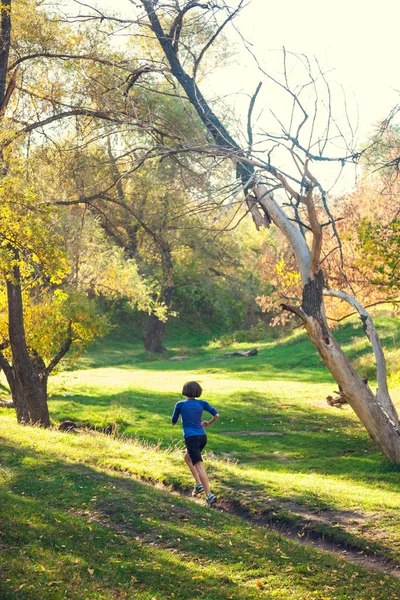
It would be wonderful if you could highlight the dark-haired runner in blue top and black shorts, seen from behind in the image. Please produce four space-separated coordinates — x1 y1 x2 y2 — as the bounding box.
171 381 219 506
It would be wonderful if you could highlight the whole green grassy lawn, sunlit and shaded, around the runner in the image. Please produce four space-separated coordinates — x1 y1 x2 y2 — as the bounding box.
0 318 400 600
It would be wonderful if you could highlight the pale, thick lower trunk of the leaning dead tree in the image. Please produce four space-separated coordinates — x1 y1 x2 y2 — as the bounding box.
254 186 400 463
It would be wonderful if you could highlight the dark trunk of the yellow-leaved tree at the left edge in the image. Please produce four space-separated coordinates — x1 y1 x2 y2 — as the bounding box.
7 266 50 427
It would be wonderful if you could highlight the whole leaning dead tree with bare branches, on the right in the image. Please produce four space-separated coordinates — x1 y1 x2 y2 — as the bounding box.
126 0 400 463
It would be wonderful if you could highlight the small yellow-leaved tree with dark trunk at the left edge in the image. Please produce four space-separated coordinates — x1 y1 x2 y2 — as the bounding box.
0 159 82 426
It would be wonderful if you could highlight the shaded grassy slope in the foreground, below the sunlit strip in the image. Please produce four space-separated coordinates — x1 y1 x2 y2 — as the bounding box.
0 440 396 600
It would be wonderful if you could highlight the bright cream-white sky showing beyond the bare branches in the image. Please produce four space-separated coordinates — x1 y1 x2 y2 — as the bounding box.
68 0 400 192
